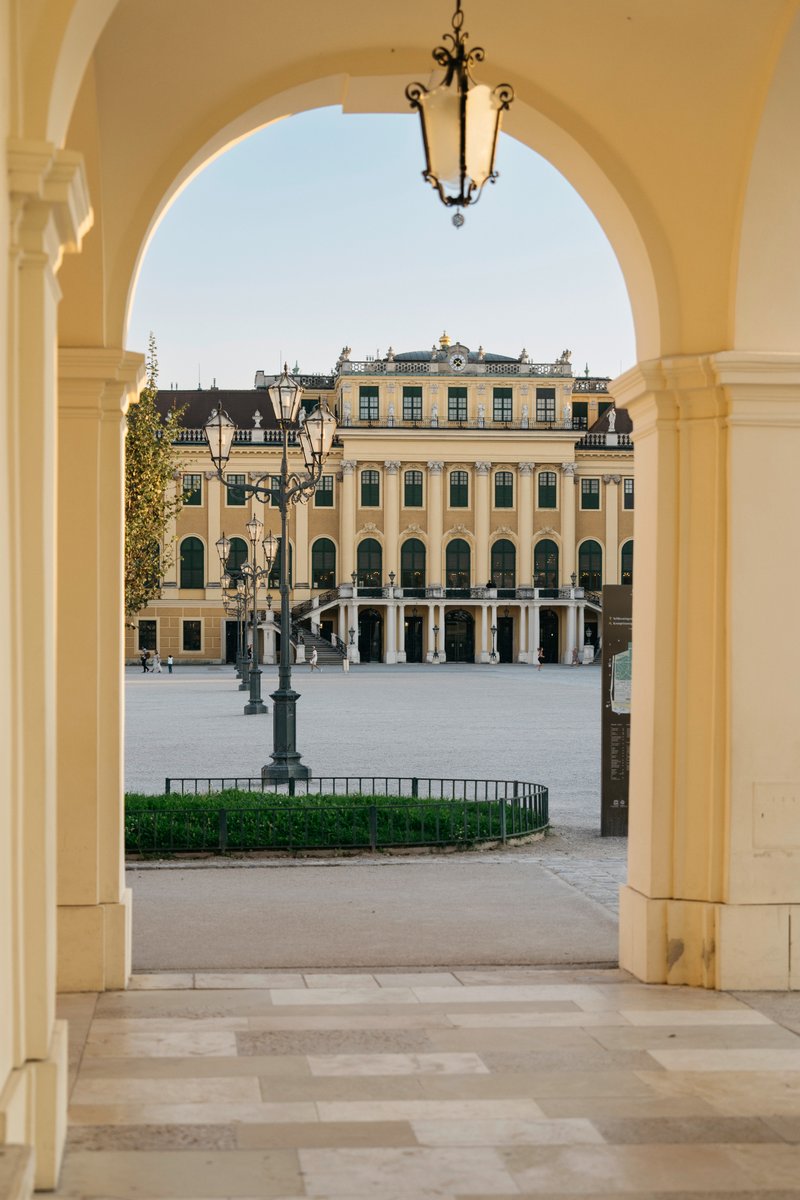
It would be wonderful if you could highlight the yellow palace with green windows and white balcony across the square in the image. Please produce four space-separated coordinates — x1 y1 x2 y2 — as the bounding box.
127 334 634 664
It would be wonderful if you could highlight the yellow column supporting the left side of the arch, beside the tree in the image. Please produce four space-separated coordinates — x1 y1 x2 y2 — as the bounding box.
58 347 144 991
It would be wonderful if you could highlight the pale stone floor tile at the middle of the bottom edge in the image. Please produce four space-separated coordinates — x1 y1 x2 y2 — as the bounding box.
299 1147 517 1200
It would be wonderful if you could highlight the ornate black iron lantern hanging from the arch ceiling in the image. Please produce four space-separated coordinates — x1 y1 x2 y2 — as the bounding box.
405 0 513 228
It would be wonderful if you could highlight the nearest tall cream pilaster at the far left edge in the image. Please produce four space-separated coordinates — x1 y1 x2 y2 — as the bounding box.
6 138 92 1189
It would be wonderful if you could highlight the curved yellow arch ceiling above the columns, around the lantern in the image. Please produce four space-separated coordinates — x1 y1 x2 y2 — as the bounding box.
56 0 798 356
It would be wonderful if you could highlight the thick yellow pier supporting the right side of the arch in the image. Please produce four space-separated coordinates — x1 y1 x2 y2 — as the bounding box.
614 352 800 989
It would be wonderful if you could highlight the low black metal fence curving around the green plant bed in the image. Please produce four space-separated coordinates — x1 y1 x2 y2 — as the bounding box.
125 775 548 854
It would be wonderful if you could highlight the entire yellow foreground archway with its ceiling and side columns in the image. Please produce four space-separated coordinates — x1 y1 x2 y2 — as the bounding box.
7 0 800 1187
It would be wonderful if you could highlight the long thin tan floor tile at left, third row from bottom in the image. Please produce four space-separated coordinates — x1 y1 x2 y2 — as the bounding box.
70 1100 317 1127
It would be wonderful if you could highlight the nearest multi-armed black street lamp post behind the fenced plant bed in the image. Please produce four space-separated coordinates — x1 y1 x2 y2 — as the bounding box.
204 364 337 782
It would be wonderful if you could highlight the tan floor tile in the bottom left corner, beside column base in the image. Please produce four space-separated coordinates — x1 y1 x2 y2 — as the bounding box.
58 1150 303 1200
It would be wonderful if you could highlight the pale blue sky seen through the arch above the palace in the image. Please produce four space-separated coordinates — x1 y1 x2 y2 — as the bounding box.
128 108 634 388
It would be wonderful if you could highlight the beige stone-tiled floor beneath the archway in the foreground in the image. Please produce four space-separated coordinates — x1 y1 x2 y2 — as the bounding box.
56 968 800 1200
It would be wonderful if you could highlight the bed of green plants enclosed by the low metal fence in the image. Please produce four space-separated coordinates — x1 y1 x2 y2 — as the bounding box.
125 790 547 854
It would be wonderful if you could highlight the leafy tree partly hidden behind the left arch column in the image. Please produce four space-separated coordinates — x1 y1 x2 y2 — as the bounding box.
125 334 184 619
